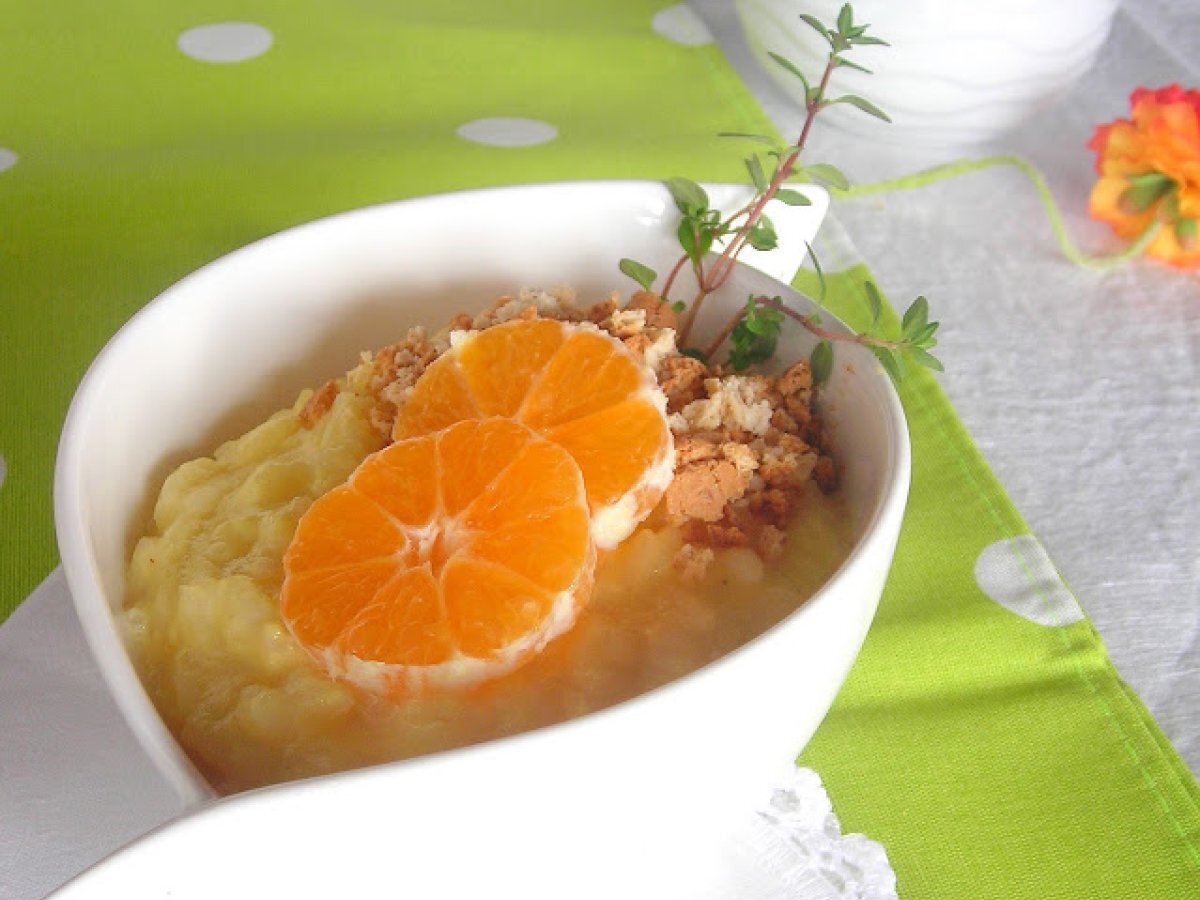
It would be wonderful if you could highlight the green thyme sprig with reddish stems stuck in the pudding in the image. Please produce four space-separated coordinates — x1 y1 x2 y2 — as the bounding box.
619 4 942 383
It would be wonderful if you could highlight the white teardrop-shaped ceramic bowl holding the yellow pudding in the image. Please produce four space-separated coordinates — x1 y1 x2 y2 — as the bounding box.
54 181 908 896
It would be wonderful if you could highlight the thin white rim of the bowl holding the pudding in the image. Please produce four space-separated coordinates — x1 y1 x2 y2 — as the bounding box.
53 179 911 810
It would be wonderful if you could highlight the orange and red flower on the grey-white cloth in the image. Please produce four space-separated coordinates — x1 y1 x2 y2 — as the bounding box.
1087 84 1200 266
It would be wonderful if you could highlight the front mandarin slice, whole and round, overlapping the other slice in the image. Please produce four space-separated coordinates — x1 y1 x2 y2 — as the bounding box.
281 418 595 695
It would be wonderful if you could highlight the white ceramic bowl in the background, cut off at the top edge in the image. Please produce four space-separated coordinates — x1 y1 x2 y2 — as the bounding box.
736 0 1118 148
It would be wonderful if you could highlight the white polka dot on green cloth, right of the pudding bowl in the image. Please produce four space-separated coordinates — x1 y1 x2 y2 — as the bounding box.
974 534 1084 626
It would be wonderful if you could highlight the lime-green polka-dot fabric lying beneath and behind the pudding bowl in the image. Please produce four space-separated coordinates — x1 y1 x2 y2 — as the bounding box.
0 0 1200 900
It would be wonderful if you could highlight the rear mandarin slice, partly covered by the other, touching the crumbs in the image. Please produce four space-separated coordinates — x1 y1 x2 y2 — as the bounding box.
392 319 674 550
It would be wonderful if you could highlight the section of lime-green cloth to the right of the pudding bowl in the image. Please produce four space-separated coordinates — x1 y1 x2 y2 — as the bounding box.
796 265 1200 900
